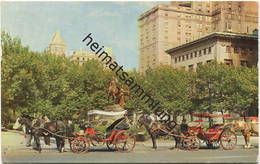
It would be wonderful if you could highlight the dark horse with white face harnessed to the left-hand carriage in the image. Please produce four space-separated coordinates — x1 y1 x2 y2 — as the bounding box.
13 115 67 153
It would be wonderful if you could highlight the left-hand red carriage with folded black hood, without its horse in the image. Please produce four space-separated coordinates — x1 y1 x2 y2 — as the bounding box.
68 118 136 153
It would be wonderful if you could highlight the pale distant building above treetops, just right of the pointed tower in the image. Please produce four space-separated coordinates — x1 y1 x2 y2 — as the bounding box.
70 47 116 67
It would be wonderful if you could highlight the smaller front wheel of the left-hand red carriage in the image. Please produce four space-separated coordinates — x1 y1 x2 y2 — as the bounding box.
70 137 90 153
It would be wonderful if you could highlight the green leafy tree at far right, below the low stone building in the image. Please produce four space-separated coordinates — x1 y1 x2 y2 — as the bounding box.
195 62 258 114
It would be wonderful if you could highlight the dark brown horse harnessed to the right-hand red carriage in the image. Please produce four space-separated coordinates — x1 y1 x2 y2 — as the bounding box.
137 115 183 150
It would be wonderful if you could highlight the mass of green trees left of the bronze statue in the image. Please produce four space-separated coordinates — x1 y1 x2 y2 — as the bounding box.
1 32 111 122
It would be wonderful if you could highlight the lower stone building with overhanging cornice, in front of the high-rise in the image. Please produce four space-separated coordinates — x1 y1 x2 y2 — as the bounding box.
166 32 258 71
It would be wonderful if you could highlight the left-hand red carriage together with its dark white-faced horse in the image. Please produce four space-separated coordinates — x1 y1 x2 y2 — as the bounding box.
13 111 136 153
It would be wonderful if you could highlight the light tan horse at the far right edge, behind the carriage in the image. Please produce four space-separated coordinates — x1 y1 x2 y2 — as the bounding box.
231 120 258 148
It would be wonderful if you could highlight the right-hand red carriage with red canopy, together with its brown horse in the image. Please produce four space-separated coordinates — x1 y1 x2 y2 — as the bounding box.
139 113 237 150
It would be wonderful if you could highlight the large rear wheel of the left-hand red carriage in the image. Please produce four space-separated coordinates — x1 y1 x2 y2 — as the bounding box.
113 130 136 152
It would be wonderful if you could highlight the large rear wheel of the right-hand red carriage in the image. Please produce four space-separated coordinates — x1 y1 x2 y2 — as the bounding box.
220 130 237 150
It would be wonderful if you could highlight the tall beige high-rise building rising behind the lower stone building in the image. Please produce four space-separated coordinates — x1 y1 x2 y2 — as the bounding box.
138 1 258 73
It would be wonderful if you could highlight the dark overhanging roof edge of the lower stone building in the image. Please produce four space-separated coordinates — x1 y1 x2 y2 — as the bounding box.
166 32 258 54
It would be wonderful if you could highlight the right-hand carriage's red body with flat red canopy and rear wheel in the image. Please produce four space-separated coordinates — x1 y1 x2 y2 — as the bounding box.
187 113 237 150
